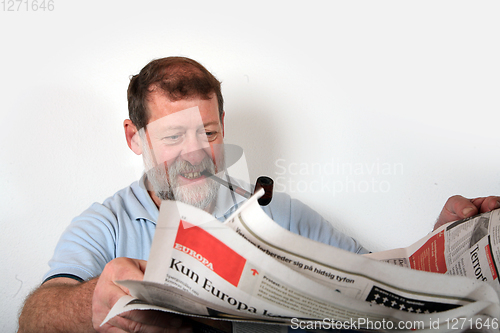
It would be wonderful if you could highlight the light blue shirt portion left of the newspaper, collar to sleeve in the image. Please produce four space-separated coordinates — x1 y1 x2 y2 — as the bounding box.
45 175 158 280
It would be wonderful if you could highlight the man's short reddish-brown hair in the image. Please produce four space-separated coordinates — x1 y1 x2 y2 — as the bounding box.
127 57 224 129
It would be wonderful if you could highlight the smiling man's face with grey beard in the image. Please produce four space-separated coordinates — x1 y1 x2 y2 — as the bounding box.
139 91 224 209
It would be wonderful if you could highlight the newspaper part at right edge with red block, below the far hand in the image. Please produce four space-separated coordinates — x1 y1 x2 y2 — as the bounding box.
366 209 500 295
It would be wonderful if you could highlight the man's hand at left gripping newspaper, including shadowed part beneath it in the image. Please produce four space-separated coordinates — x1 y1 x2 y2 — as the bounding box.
92 258 191 333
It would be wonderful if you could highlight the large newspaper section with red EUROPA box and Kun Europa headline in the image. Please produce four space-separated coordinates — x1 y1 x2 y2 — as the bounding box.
104 192 500 332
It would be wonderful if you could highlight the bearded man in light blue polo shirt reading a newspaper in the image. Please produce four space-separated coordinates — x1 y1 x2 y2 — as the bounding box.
19 57 500 333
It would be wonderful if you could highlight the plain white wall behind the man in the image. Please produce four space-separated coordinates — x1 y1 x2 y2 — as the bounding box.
0 0 500 332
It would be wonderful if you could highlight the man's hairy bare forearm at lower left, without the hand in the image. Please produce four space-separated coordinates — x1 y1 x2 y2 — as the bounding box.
18 278 98 333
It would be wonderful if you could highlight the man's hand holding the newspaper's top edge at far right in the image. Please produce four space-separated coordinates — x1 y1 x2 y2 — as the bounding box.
434 195 500 230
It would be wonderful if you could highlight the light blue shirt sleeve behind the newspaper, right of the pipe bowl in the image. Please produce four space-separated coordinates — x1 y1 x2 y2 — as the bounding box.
264 193 370 254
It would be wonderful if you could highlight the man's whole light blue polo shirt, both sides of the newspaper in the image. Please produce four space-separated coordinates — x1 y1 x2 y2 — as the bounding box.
44 176 368 281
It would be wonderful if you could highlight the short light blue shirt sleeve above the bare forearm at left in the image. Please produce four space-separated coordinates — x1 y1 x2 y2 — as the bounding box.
44 203 117 281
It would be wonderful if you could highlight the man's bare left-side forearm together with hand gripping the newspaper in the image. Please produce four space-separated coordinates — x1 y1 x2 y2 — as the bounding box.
18 258 191 333
